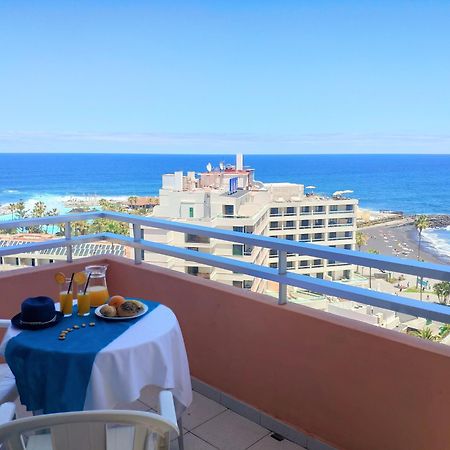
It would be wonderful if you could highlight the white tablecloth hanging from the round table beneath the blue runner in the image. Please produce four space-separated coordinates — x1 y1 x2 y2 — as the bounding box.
0 305 192 410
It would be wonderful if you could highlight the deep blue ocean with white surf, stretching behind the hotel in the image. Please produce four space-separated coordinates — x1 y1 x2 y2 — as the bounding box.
0 154 450 255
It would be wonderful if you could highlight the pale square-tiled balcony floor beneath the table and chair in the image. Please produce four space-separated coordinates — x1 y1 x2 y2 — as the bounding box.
17 392 310 450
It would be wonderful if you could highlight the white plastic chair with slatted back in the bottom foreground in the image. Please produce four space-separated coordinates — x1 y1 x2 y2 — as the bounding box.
0 391 179 450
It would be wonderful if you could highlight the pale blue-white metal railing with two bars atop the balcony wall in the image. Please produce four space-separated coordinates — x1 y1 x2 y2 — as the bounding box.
0 211 450 323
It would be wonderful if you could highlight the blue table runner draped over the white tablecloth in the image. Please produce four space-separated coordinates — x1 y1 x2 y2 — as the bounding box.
5 299 159 414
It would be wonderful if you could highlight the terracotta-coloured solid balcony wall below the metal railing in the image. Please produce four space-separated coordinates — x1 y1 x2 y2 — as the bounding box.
0 257 450 450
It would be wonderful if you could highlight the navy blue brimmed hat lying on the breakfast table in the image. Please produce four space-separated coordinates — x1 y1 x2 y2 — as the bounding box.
11 297 64 330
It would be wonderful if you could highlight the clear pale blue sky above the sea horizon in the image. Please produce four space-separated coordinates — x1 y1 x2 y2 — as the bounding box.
0 0 450 153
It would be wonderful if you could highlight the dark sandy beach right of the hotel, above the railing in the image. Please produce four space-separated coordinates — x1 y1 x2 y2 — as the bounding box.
360 220 442 264
